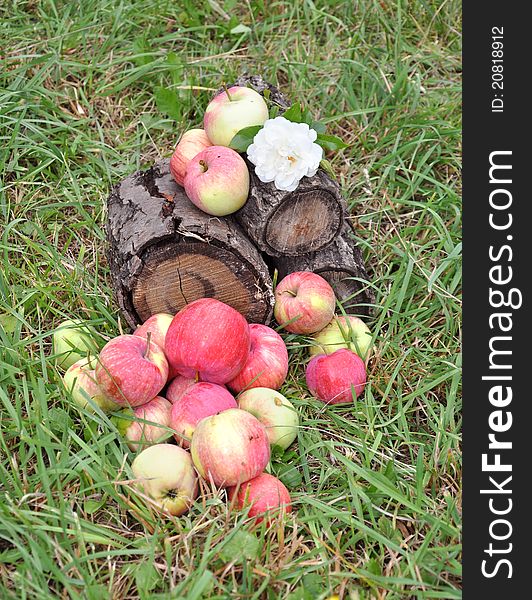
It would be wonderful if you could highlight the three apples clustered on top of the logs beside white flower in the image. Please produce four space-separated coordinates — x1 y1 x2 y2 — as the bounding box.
170 86 268 217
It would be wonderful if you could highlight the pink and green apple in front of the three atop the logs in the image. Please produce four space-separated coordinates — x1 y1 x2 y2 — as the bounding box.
184 146 249 217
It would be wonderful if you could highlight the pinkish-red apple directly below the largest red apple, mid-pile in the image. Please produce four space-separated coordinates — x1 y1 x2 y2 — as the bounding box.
170 382 237 448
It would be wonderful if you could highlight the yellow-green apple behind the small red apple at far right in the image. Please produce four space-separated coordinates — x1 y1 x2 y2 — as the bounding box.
310 315 371 363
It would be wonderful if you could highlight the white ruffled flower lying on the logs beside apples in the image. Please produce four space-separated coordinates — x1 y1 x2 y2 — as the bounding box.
247 117 323 192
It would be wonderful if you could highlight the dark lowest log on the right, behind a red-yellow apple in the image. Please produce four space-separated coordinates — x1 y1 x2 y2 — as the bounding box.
271 222 375 315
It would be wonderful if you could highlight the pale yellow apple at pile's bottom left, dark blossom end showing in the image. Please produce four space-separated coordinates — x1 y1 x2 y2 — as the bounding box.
131 444 198 516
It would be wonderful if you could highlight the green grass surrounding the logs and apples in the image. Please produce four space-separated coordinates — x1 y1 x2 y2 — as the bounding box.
0 0 461 600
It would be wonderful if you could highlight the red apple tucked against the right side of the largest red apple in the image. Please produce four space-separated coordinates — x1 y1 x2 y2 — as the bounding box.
227 323 288 393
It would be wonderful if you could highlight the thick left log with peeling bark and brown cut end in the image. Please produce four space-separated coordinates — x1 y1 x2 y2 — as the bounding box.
107 160 273 327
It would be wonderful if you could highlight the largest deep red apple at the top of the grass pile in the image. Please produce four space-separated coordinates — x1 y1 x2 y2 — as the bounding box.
165 298 250 384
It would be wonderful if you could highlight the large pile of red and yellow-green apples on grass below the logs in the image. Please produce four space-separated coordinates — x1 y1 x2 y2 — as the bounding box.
53 272 371 520
